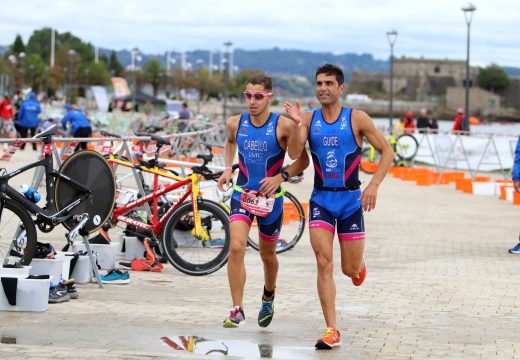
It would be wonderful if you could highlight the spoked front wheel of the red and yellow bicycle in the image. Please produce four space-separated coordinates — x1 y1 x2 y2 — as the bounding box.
162 199 230 276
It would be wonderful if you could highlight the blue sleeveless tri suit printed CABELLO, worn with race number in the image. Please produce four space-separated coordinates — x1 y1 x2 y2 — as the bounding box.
229 113 285 241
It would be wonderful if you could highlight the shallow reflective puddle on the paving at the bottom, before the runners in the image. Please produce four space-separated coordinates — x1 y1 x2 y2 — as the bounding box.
161 336 315 359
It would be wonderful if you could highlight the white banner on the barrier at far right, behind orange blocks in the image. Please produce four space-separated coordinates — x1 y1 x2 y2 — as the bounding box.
414 133 517 171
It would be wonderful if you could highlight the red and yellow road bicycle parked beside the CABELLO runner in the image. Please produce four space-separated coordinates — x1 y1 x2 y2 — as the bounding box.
103 133 230 276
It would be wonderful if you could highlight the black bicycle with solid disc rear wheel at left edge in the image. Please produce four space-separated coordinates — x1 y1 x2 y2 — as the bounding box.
0 126 115 266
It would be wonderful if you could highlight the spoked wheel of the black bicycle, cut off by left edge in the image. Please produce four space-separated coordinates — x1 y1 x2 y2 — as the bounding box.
0 199 37 265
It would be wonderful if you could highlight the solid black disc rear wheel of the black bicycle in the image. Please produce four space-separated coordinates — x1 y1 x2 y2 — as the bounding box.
55 150 116 234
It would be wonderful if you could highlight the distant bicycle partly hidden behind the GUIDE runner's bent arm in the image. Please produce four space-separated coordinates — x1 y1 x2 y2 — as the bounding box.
360 134 419 174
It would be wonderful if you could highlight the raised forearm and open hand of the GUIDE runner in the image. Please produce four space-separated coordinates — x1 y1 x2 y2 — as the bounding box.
284 100 312 160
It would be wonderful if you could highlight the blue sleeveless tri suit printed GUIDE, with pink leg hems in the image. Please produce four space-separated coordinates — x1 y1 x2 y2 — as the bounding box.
309 107 365 241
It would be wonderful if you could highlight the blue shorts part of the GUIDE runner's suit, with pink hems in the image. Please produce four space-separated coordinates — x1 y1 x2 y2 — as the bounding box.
309 189 365 241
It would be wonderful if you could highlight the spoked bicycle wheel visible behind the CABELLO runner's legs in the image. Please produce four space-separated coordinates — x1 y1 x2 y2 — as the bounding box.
247 191 305 254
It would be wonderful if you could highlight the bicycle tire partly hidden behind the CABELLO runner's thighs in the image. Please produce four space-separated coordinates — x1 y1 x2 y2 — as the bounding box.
247 191 305 254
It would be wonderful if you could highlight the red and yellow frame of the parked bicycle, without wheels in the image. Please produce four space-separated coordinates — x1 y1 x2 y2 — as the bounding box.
108 155 203 238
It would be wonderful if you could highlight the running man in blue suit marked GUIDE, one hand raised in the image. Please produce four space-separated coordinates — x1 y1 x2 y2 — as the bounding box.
284 64 393 349
